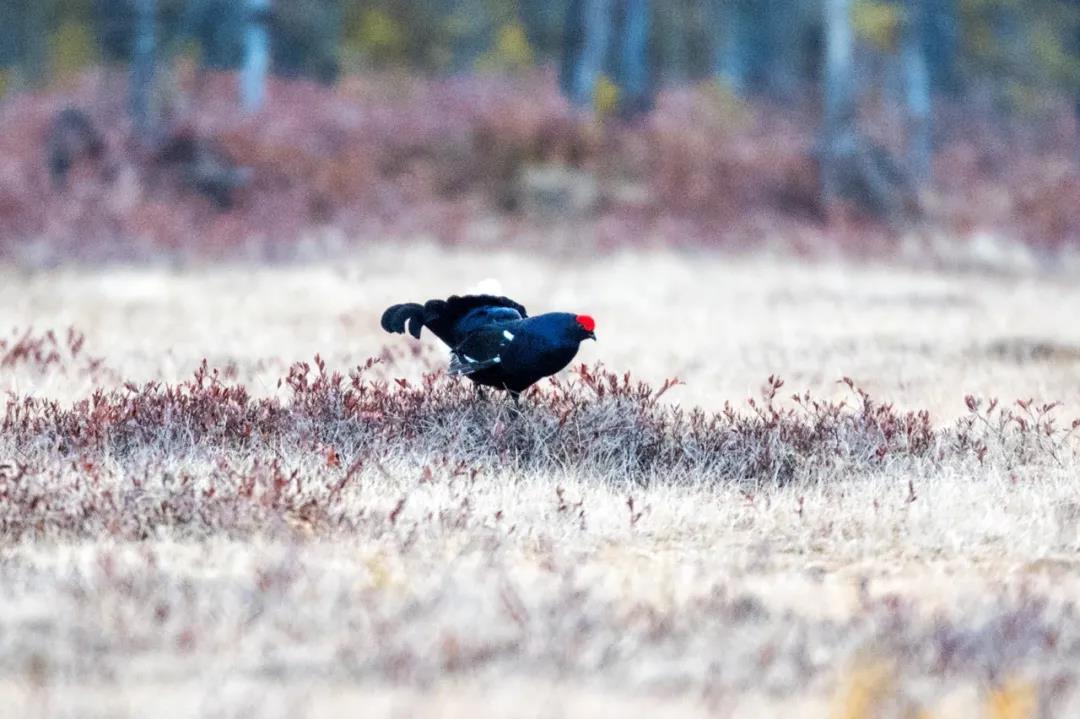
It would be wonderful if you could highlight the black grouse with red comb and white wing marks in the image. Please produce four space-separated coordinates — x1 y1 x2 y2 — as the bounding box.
382 295 596 401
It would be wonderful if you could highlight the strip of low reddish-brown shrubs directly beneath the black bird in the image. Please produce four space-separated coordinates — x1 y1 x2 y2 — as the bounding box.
0 338 1080 508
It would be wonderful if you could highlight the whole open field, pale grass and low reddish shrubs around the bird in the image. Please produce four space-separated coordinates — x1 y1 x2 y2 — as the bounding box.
0 247 1080 718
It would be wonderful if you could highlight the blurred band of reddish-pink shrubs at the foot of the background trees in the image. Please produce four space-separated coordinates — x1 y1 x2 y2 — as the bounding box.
0 69 1080 260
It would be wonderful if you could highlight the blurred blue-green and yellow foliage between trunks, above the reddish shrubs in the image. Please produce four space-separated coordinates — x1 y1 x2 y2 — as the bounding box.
0 0 1080 114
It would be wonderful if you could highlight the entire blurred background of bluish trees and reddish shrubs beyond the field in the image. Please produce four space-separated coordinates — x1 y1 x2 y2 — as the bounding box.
0 0 1080 267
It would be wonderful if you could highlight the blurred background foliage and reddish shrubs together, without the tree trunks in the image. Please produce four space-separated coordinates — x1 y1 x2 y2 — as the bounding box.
0 0 1080 260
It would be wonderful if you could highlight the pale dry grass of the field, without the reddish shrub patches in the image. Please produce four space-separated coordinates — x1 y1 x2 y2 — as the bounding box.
0 247 1080 717
